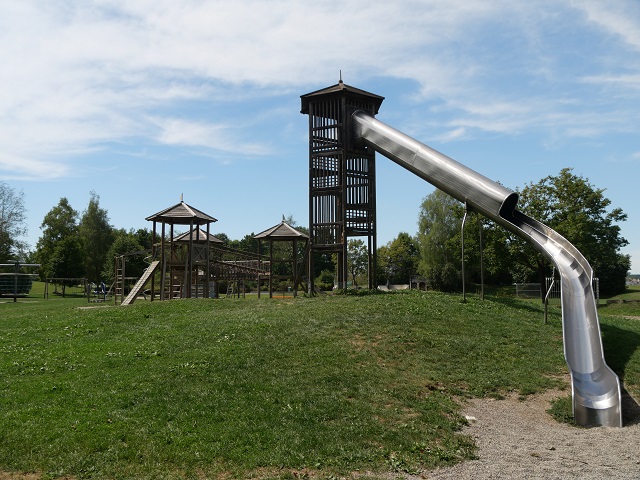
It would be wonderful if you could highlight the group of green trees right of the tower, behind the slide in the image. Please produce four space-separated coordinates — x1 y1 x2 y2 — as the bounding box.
378 168 631 294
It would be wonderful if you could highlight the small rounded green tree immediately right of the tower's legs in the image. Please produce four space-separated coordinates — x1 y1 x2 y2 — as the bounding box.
378 232 420 284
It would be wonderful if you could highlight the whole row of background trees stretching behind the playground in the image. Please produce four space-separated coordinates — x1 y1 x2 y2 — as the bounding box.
0 168 631 294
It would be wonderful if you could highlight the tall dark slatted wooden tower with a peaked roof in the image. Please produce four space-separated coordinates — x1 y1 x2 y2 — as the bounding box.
300 79 384 293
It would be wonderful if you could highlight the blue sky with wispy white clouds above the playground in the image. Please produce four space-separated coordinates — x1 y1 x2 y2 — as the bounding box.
0 0 640 274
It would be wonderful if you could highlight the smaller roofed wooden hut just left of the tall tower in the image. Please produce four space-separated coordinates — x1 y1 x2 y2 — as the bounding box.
253 218 309 298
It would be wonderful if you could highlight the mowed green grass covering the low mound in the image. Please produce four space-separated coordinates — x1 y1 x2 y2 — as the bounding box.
0 292 640 479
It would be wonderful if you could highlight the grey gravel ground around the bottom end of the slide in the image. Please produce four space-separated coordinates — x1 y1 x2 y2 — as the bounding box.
418 391 640 480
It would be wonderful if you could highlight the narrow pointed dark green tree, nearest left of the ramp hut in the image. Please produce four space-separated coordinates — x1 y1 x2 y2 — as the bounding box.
78 191 114 283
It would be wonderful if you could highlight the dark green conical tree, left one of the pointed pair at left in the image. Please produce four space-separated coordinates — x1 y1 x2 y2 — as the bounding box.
36 197 79 279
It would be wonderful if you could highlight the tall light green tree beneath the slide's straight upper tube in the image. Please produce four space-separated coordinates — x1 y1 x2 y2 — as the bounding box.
418 189 464 291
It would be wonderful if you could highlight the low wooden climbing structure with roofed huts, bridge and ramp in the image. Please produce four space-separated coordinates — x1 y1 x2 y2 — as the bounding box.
113 201 308 305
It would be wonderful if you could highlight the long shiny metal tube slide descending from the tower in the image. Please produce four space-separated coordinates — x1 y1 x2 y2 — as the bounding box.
351 110 622 427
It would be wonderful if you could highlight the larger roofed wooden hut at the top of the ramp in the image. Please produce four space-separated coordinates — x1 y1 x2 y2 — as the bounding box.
146 201 218 300
